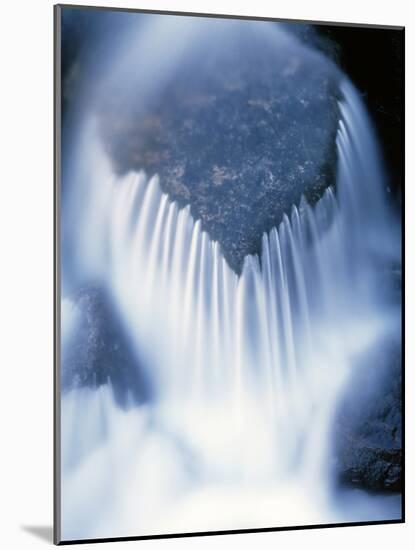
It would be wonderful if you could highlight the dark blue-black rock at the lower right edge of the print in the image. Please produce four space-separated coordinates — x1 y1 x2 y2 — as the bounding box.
335 342 402 491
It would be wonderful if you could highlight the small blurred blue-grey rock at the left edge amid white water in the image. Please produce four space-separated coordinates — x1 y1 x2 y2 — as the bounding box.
61 286 151 406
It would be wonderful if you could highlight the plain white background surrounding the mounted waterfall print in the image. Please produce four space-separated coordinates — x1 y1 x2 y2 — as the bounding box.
0 0 415 550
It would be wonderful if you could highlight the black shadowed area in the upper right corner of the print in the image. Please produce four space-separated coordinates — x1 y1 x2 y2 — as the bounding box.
315 25 405 205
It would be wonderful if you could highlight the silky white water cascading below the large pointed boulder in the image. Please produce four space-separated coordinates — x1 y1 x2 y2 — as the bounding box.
62 81 402 539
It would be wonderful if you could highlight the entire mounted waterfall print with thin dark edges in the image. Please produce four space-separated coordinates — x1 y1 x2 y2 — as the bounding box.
55 5 404 544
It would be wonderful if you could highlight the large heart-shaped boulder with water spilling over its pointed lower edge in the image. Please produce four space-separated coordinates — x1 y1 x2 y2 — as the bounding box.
98 20 339 272
